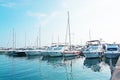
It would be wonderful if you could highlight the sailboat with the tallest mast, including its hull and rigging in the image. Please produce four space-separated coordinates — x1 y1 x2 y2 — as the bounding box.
63 12 80 56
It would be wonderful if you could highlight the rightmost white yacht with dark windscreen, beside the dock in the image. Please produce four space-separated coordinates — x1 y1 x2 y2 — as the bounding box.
104 44 120 58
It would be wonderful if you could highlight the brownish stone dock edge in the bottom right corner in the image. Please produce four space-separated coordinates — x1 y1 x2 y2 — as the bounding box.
110 57 120 80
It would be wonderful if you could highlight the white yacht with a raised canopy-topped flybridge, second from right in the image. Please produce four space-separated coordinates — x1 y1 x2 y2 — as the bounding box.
83 40 104 58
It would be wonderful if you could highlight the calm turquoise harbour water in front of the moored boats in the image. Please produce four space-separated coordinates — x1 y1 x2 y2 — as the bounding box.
0 55 117 80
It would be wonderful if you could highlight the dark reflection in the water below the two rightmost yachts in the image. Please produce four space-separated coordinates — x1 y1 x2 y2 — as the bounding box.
84 58 118 74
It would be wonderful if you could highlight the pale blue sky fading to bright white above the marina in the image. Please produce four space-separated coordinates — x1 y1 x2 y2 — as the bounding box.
0 0 120 47
